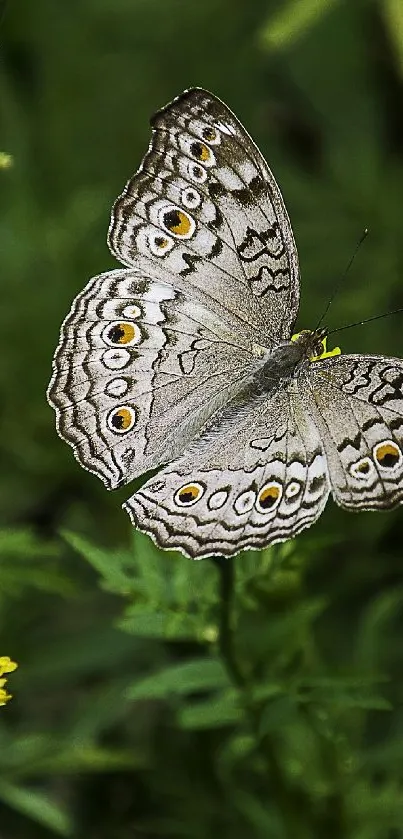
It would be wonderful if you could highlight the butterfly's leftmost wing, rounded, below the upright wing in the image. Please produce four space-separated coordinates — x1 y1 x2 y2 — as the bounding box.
48 269 261 489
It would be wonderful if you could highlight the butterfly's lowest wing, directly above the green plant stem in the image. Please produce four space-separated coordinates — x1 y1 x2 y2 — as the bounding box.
123 382 329 559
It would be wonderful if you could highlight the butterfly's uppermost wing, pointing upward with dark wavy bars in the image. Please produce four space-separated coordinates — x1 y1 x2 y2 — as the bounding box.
109 88 299 346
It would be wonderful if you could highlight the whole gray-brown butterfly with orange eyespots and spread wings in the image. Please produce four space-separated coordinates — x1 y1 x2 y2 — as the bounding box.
48 89 403 559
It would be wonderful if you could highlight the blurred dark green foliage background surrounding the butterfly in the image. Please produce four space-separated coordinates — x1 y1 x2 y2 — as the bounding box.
0 0 403 839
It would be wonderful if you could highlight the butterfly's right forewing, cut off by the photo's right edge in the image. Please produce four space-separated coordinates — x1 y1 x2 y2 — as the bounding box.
308 355 403 510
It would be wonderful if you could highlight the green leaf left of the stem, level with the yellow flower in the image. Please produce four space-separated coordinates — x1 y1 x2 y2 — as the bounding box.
126 658 229 699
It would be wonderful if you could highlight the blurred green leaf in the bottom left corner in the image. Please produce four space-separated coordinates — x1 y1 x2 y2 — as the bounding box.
0 781 73 836
